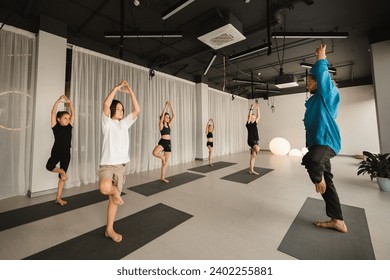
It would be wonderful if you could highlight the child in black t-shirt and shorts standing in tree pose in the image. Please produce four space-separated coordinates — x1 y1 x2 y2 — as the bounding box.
46 95 74 205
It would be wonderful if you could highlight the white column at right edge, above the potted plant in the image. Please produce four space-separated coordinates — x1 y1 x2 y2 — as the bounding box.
371 40 390 153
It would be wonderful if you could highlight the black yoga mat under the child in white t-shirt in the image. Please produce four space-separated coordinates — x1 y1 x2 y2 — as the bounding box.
25 203 193 260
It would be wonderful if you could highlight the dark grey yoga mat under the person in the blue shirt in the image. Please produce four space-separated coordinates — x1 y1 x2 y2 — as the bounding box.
278 197 375 260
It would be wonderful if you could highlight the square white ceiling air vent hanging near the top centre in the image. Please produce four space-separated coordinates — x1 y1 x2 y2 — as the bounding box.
198 11 245 50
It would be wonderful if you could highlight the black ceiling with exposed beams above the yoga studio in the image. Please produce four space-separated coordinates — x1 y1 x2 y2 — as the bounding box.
0 0 390 98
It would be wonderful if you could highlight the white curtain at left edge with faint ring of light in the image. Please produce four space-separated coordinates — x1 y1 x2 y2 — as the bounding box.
0 24 35 199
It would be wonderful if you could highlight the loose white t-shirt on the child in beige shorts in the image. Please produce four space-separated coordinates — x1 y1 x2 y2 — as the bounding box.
100 114 137 165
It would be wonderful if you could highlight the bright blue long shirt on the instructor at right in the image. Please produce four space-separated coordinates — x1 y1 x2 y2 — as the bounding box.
304 59 341 154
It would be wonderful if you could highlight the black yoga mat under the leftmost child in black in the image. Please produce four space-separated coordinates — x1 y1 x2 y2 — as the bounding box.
0 190 116 231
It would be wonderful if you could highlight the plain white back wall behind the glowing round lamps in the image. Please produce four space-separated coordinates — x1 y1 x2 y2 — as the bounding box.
259 85 379 155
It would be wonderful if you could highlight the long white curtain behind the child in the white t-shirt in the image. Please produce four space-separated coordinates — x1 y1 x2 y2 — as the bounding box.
67 47 196 186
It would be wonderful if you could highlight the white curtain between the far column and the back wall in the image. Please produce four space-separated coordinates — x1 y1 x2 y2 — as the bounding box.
204 89 249 156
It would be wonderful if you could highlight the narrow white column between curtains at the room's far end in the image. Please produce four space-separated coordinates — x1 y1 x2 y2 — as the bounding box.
195 83 209 160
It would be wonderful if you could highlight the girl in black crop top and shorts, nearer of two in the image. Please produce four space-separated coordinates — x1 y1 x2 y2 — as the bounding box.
152 101 175 183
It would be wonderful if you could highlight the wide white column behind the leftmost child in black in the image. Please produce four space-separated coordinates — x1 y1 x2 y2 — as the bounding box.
29 31 67 196
